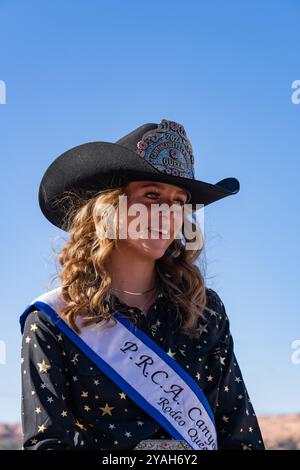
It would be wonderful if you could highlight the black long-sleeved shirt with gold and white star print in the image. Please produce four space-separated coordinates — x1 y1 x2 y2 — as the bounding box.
21 288 265 450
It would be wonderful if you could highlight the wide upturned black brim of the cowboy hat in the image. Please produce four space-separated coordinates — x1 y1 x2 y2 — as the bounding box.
39 142 240 228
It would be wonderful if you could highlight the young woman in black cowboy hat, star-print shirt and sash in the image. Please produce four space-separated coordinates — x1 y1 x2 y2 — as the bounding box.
20 119 264 450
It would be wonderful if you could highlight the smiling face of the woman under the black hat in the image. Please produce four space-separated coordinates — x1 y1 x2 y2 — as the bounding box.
118 181 188 260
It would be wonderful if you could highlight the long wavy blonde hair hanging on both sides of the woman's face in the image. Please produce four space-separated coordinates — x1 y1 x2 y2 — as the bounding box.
49 185 207 337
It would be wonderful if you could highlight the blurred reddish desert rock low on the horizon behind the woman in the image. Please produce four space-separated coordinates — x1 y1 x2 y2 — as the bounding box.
0 413 300 450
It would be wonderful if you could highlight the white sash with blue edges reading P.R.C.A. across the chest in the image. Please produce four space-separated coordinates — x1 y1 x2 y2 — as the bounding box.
20 287 217 450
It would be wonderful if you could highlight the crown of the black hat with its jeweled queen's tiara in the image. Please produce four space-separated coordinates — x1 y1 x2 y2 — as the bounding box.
116 119 195 179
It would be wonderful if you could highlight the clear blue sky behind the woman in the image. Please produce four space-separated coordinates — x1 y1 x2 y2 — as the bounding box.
0 0 300 422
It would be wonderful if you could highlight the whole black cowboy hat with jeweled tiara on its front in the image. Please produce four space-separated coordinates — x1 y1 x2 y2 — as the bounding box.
39 119 240 229
